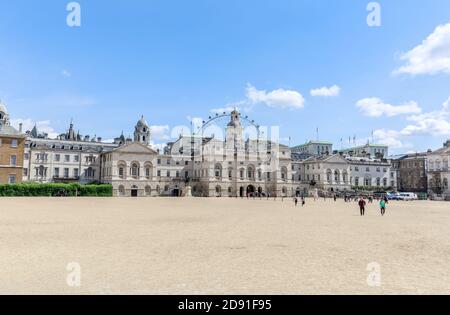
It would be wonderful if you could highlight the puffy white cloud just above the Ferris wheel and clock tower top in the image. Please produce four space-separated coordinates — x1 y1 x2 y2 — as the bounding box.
247 85 305 109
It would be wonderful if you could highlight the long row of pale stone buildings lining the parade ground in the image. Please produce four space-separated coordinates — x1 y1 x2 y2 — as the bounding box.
0 100 450 197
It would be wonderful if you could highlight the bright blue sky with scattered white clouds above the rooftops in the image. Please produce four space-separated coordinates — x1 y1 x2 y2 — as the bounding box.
0 0 450 153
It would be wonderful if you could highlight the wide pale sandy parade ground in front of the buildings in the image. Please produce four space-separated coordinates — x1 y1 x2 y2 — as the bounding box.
0 198 450 294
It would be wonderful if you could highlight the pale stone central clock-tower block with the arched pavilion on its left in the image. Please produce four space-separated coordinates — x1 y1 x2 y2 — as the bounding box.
100 111 294 197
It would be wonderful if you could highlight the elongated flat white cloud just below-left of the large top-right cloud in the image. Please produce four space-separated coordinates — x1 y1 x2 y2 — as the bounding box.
356 97 422 117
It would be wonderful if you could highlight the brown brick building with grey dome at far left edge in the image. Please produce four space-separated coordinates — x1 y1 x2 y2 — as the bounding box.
0 101 26 184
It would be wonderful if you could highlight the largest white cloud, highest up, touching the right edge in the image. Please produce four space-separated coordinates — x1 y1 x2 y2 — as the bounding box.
394 23 450 75
